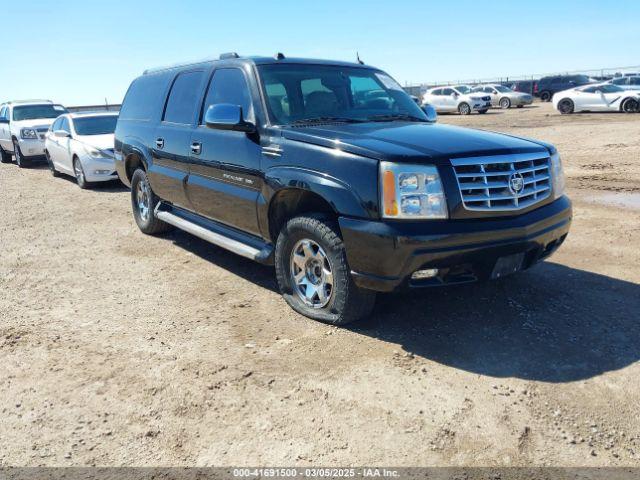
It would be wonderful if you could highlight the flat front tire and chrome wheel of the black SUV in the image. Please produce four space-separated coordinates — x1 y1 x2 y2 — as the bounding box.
275 215 376 325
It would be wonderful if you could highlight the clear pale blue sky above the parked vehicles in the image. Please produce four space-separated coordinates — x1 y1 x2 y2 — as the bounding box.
0 0 640 105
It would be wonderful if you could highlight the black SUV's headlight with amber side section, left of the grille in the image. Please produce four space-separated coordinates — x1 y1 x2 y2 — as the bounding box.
380 162 448 220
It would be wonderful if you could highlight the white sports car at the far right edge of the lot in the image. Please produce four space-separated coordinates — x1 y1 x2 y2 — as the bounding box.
553 83 640 114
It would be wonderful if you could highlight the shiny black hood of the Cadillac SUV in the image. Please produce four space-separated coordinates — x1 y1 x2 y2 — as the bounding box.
283 122 552 163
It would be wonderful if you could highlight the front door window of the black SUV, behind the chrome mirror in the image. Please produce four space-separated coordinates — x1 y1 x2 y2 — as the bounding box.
200 68 253 123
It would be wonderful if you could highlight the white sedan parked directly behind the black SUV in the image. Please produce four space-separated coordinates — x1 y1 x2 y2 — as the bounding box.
45 112 118 188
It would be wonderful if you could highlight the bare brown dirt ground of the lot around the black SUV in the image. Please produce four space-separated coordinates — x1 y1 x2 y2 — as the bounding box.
0 104 640 466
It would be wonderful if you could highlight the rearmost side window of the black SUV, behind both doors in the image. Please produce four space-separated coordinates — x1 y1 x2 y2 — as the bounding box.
120 75 168 120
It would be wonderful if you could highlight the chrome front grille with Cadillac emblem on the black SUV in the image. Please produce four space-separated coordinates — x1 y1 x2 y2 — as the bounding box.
451 153 551 211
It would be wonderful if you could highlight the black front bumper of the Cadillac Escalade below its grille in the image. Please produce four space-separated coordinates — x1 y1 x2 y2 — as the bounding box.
340 197 572 292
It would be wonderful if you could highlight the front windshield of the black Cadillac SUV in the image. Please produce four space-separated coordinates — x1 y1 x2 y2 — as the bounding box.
258 64 427 125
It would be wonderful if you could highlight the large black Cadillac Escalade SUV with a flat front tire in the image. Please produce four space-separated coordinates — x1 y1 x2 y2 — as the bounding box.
115 54 571 324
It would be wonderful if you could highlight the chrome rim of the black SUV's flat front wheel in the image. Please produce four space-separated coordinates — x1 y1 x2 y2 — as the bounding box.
290 238 333 308
